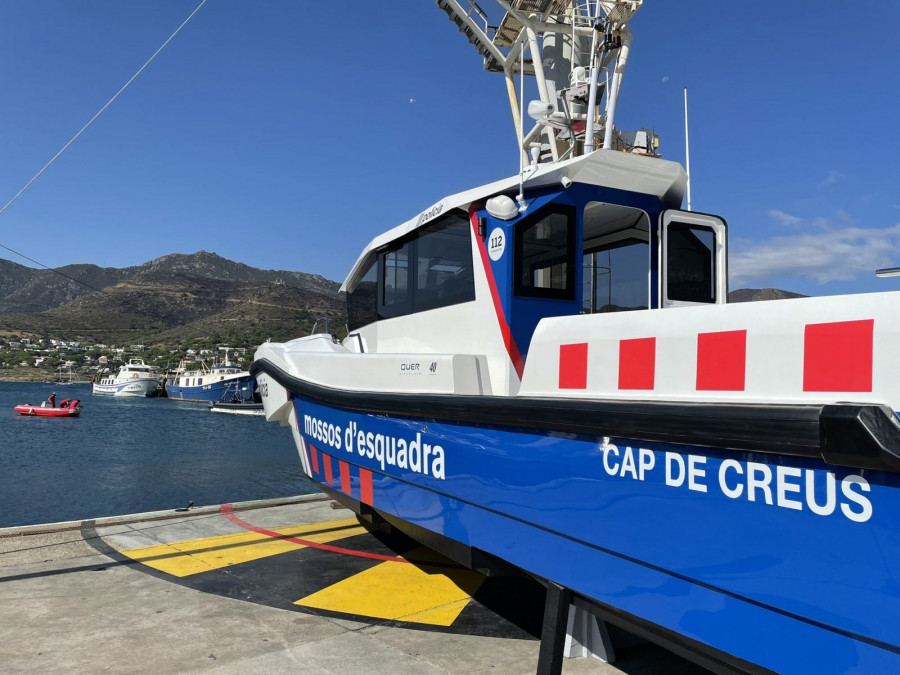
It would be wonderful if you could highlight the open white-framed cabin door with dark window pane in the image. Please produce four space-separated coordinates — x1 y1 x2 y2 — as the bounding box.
658 209 728 307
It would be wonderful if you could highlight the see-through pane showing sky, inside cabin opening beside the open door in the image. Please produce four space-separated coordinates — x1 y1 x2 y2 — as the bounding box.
582 239 650 314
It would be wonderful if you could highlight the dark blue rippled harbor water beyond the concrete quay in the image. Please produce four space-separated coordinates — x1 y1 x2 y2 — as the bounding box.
0 382 317 527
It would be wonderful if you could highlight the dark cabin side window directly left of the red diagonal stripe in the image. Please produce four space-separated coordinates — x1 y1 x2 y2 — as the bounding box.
413 216 475 312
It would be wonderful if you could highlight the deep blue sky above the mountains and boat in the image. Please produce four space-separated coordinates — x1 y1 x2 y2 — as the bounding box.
0 0 900 295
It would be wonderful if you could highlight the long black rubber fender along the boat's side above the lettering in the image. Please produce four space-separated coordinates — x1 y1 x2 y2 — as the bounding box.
250 359 900 473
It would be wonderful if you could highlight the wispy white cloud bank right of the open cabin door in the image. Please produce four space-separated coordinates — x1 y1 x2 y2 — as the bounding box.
728 223 900 288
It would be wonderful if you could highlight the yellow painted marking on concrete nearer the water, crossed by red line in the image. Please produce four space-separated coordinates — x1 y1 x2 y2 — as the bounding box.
121 518 366 577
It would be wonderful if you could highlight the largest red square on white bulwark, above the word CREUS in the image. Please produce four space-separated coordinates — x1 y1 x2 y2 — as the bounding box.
803 319 875 391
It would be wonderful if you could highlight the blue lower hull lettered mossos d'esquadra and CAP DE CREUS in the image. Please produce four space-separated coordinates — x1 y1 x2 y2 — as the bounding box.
292 393 900 673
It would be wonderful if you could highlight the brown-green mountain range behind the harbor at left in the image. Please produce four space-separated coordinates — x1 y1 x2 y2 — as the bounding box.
0 251 346 344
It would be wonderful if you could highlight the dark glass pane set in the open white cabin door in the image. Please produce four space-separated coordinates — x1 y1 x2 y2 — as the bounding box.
666 222 716 303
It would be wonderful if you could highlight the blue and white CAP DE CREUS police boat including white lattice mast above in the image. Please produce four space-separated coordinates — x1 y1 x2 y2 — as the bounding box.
251 0 900 673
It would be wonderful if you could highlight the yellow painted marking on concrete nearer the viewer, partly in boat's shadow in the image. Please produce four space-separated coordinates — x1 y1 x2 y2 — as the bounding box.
294 548 484 626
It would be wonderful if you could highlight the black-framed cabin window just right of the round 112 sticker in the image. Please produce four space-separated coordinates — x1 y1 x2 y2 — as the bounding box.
514 209 575 300
